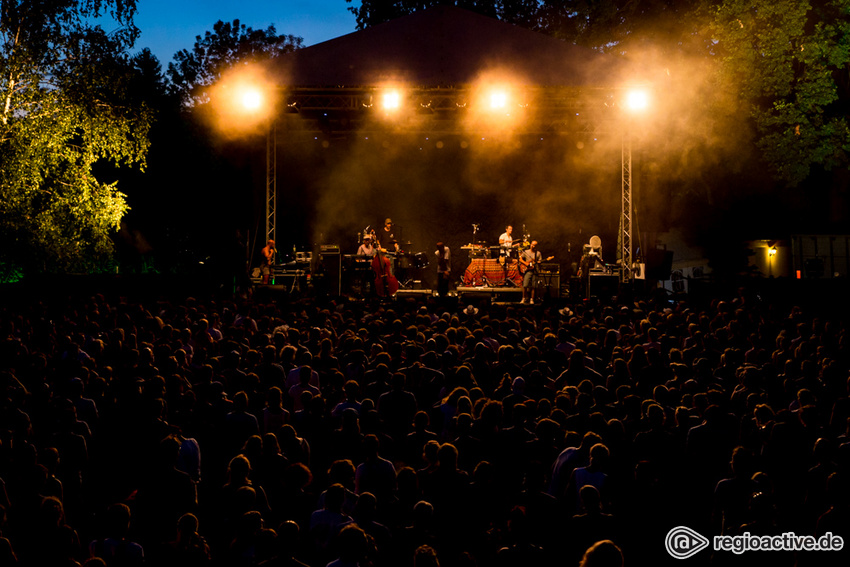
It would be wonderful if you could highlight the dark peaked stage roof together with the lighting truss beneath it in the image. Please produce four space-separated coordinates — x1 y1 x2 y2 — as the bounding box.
264 6 634 125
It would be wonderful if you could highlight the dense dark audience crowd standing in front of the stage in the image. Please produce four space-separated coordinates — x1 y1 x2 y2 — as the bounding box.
0 288 850 567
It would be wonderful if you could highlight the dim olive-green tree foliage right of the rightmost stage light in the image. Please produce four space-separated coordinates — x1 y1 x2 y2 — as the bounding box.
712 0 850 185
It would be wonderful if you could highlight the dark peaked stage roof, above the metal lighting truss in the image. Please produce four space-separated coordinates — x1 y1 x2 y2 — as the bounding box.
275 6 622 88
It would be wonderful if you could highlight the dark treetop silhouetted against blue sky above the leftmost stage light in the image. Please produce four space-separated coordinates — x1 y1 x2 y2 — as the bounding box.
168 20 303 106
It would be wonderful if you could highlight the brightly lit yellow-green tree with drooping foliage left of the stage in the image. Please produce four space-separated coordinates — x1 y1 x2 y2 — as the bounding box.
0 0 150 276
